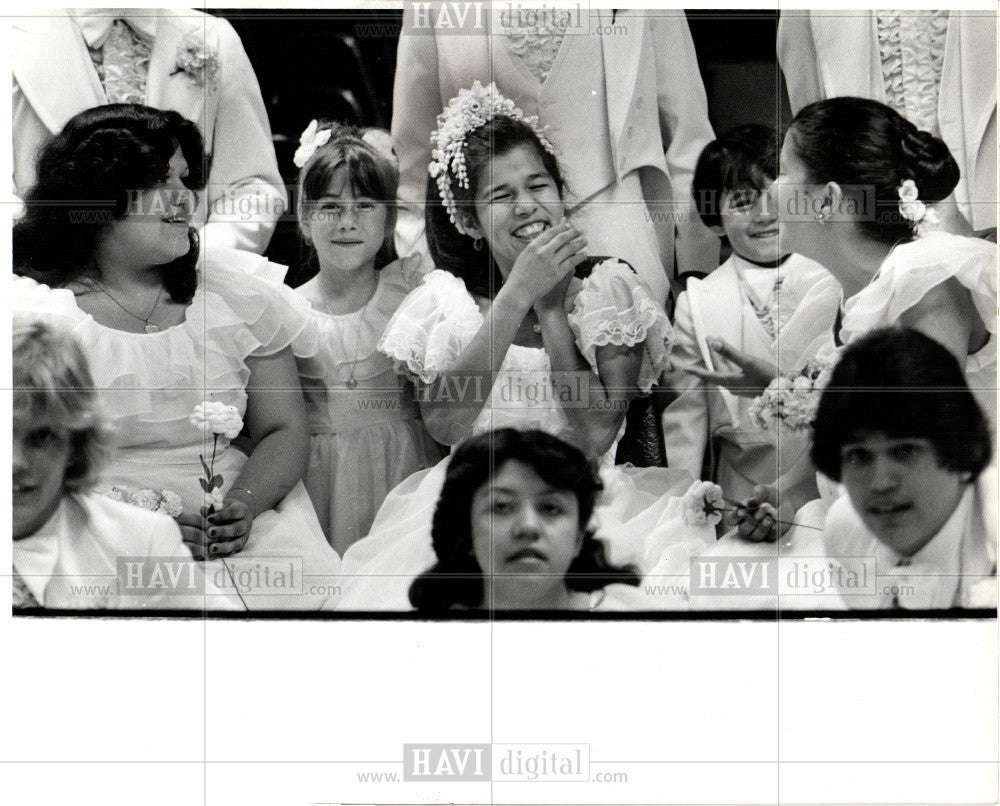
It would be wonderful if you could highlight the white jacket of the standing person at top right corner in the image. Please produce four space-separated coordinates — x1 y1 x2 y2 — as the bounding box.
778 11 997 230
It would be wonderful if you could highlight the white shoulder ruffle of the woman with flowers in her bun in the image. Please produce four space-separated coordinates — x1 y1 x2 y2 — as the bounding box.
843 232 997 340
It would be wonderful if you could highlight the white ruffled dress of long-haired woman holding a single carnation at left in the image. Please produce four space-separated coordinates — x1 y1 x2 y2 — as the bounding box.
13 254 340 610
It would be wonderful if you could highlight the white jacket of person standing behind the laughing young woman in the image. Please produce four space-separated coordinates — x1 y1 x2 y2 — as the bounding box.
392 7 719 301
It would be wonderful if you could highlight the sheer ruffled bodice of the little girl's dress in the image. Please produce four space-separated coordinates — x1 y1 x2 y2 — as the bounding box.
292 261 412 383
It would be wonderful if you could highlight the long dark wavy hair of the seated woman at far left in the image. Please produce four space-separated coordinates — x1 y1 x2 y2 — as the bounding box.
13 104 207 302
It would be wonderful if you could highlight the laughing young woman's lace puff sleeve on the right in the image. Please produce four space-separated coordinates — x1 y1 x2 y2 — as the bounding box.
567 260 674 394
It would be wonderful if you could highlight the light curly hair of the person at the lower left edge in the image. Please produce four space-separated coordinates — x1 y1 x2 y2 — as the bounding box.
13 314 107 492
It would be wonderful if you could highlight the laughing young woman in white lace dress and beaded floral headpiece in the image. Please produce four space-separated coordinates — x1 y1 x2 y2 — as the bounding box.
330 82 714 610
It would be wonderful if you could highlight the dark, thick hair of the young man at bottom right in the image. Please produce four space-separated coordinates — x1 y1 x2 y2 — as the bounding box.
811 327 992 481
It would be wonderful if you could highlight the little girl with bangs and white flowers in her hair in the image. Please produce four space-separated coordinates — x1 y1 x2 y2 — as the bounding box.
294 121 441 554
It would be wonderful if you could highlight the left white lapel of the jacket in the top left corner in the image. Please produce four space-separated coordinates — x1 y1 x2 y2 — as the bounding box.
11 14 108 134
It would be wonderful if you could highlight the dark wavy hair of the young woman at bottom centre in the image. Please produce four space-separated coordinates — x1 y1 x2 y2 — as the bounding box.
410 428 639 612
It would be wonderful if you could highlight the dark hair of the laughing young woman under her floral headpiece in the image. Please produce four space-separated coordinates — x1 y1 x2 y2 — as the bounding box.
425 115 566 299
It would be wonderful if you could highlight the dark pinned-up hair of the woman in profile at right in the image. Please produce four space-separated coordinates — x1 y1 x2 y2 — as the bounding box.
788 98 961 244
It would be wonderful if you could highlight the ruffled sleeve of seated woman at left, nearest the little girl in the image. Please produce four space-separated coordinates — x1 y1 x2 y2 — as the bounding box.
200 247 310 358
